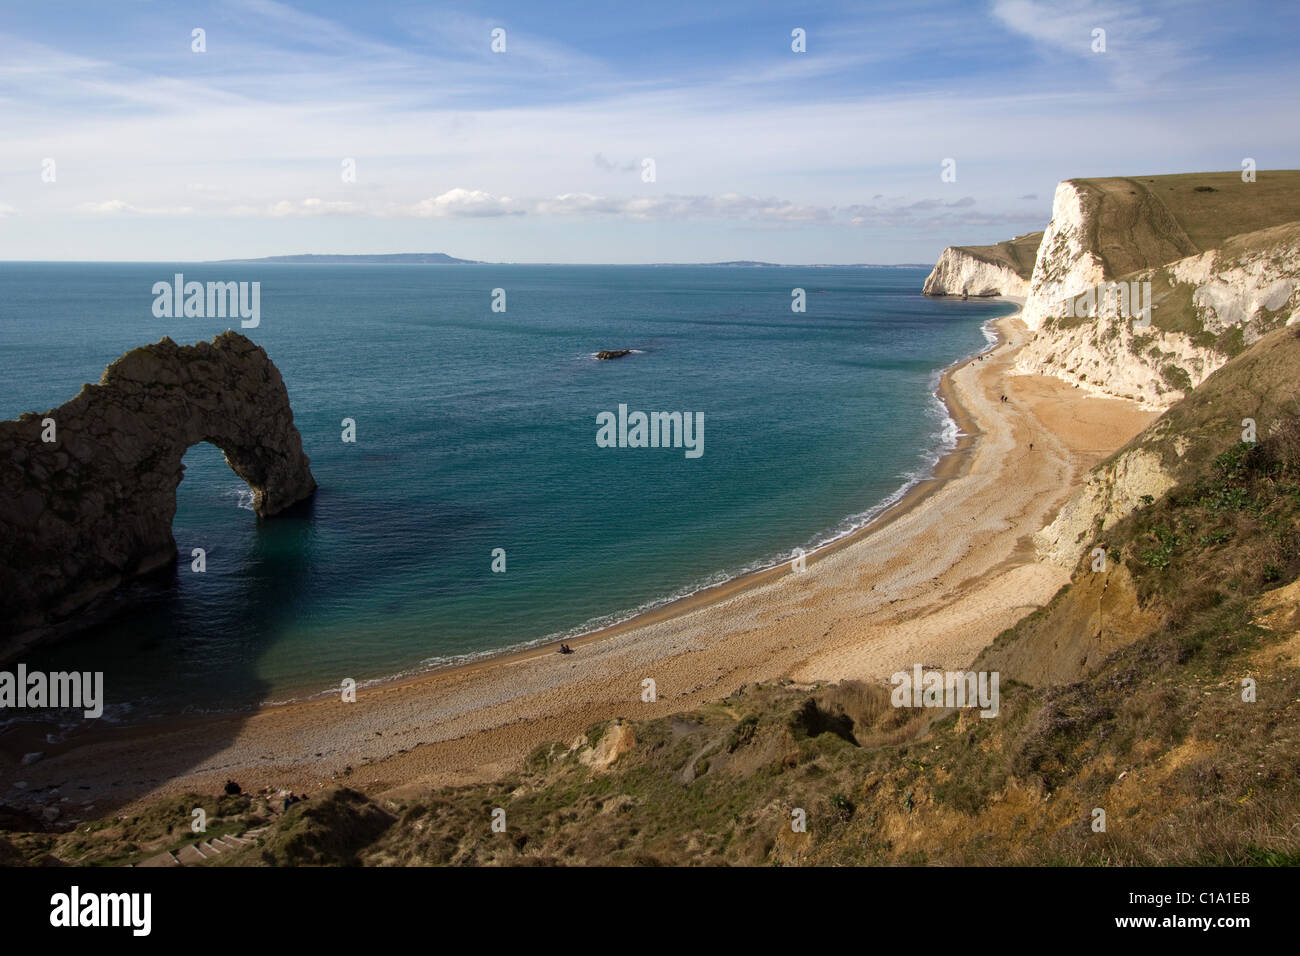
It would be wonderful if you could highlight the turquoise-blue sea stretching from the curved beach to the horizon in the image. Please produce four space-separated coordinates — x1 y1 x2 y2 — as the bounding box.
0 263 1010 719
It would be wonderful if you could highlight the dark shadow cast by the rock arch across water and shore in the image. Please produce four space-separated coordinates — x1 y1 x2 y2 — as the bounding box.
0 445 316 816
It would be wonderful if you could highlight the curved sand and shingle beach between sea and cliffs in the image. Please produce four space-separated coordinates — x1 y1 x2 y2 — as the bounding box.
2 316 1154 817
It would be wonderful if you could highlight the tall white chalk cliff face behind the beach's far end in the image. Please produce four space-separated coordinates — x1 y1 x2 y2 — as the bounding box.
1017 177 1300 408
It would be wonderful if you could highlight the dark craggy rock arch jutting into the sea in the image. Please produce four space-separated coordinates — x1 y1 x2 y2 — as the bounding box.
0 332 316 647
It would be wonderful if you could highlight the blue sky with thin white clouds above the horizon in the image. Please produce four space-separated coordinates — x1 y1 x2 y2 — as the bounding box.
0 0 1300 264
